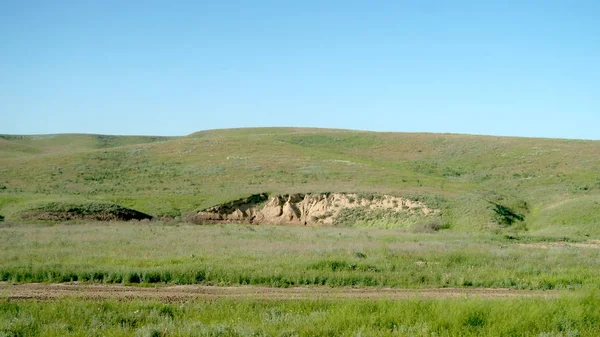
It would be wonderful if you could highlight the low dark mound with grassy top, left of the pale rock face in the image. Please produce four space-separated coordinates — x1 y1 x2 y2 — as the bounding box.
19 202 152 221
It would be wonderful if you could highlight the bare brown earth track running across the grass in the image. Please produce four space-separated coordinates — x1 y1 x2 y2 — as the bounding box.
0 283 563 302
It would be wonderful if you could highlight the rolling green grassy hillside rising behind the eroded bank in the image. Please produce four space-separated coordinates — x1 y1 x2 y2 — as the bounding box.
0 128 600 237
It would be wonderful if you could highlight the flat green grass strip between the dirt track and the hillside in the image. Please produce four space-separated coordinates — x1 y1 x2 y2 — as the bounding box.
0 222 600 290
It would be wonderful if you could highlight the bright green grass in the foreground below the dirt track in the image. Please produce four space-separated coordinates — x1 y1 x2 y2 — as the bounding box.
0 293 600 337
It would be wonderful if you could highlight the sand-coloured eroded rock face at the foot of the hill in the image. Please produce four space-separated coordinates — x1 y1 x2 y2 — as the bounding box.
194 193 439 226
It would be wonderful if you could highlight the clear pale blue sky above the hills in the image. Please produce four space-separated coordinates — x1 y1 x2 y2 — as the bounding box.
0 0 600 139
